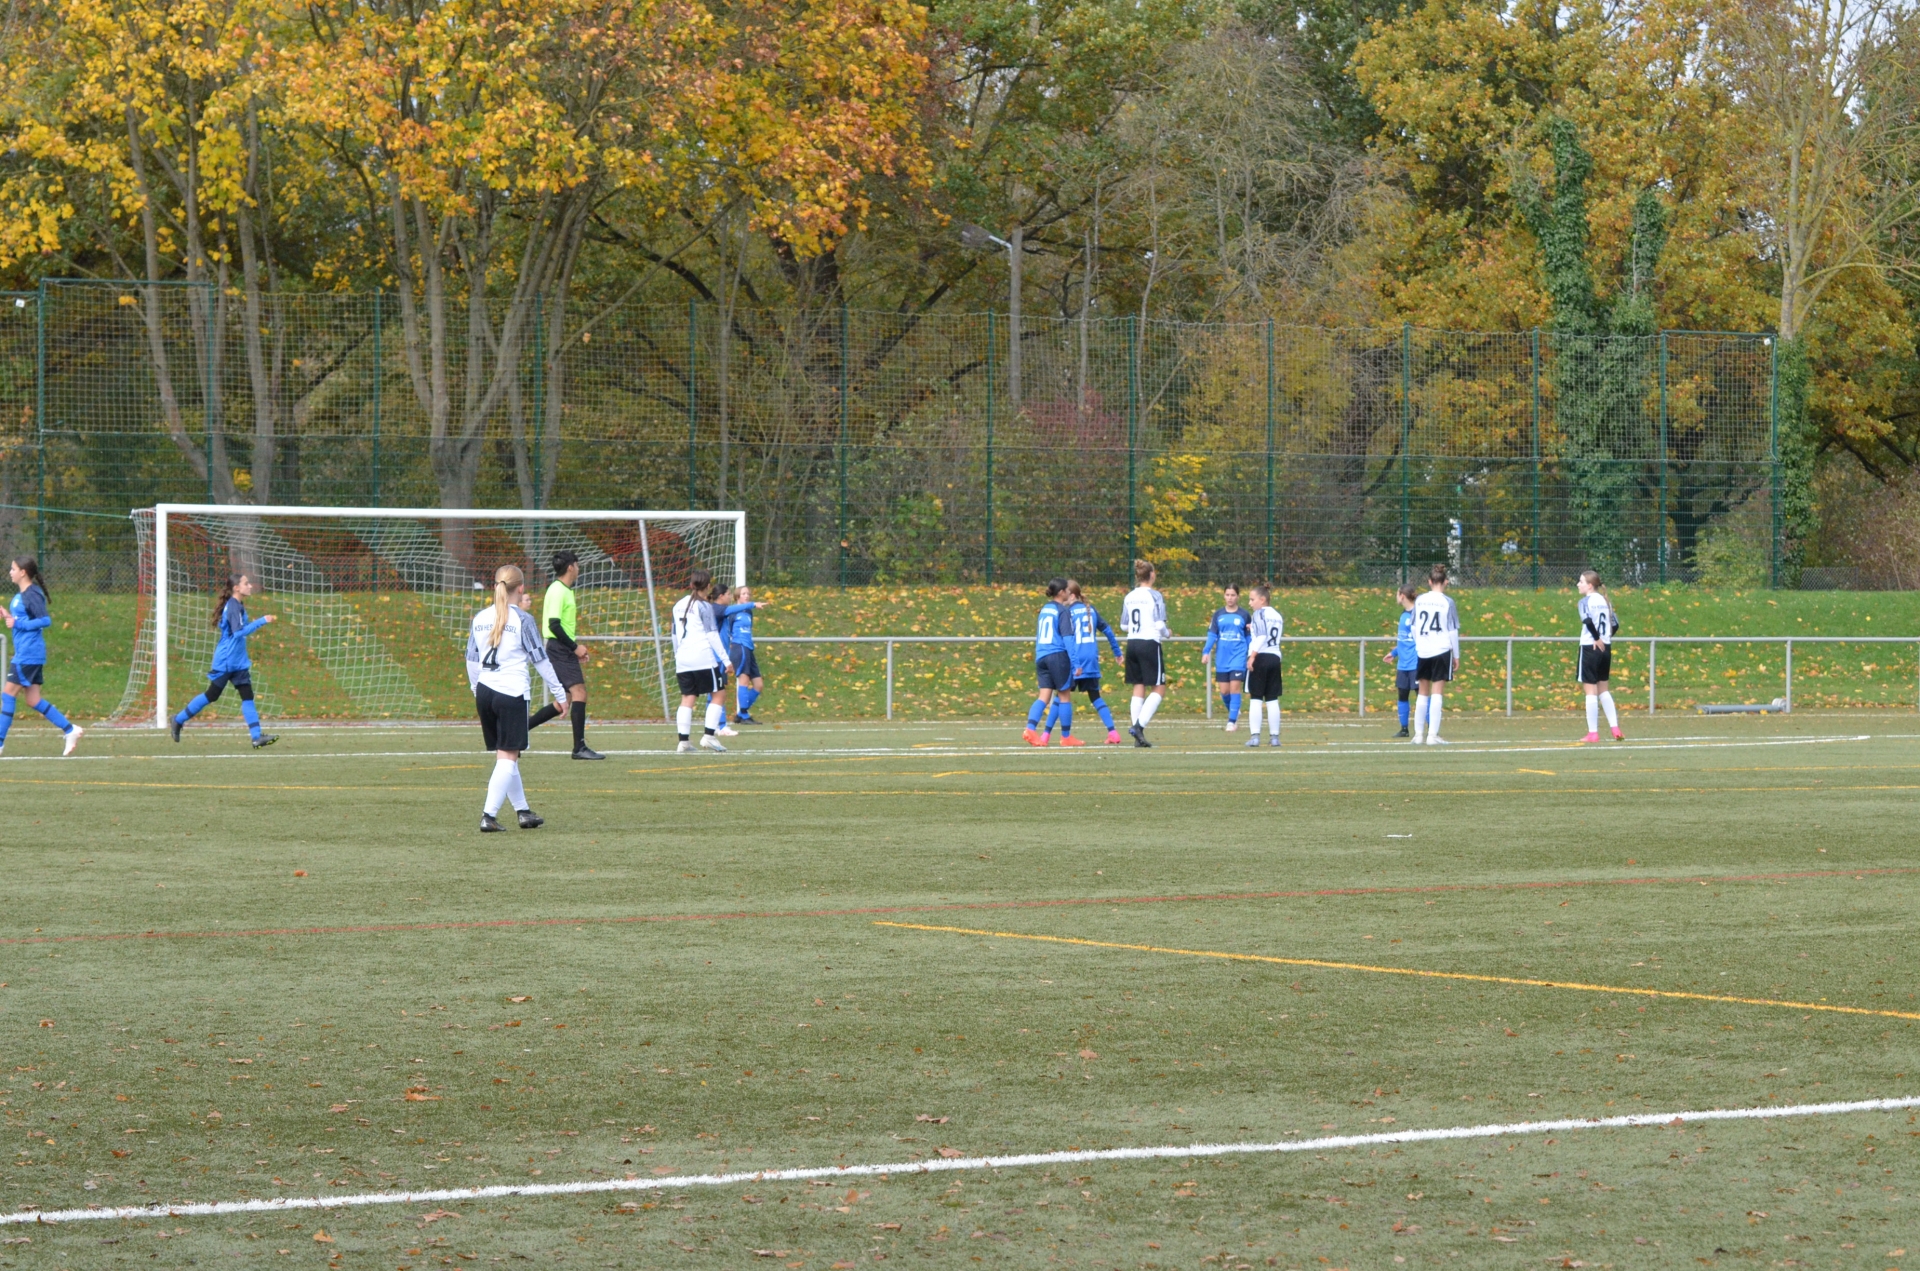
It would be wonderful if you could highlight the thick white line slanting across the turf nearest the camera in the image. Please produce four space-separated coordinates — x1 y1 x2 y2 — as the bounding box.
0 1096 1920 1225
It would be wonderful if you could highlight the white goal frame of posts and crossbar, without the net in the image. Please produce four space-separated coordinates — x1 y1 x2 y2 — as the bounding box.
154 503 747 728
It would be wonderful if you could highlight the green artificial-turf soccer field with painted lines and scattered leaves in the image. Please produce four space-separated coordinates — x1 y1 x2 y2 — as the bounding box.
0 710 1920 1271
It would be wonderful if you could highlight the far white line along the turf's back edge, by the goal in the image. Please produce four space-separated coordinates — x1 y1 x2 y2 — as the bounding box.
0 733 1889 768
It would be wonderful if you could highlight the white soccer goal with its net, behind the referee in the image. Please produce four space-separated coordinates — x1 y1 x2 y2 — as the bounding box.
111 503 747 728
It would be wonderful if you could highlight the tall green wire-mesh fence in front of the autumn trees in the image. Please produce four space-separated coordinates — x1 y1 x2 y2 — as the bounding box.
0 280 1780 586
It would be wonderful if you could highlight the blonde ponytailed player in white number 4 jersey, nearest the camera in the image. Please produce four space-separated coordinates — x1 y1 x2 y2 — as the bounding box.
467 564 566 833
